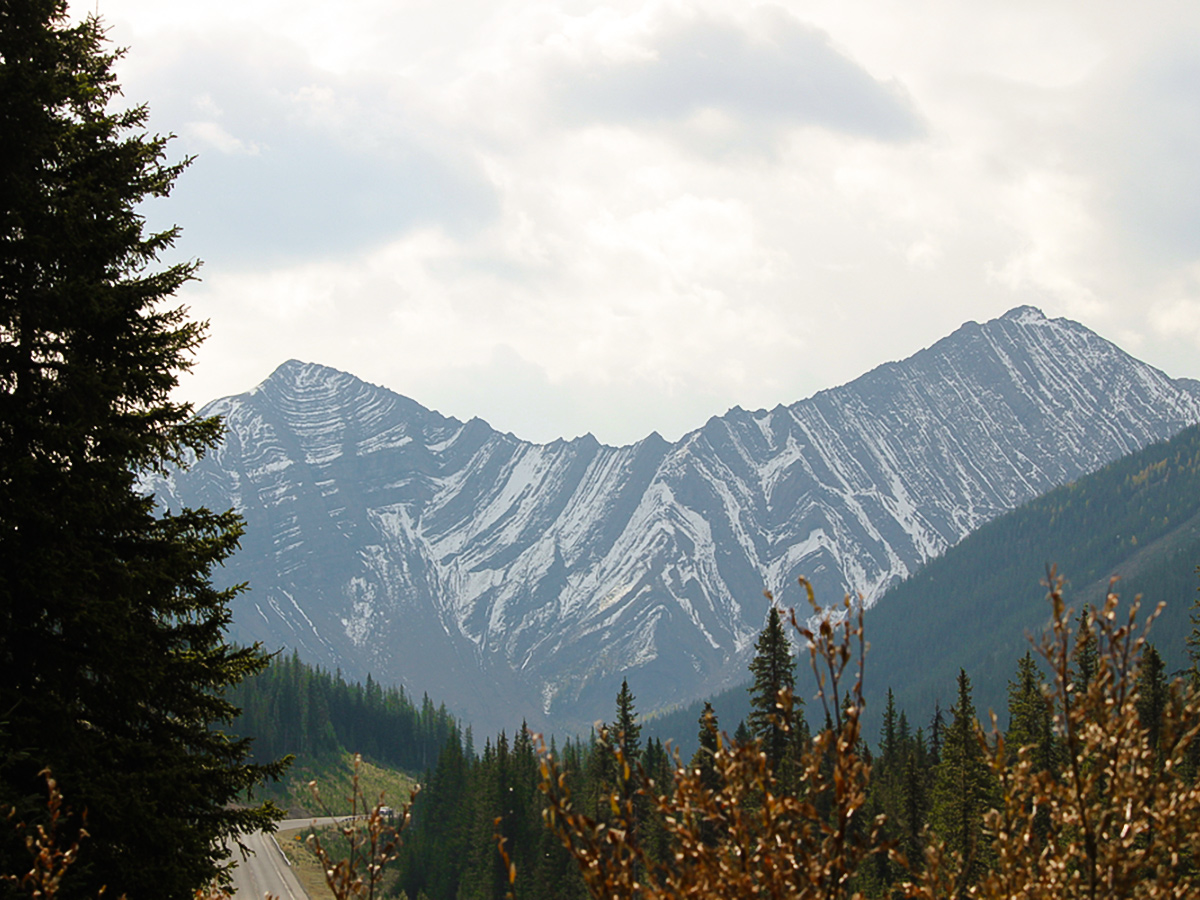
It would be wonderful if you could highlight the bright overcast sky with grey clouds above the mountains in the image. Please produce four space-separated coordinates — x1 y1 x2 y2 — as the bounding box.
88 0 1200 443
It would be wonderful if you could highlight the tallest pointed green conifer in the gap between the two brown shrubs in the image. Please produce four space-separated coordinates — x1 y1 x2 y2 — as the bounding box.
930 670 998 884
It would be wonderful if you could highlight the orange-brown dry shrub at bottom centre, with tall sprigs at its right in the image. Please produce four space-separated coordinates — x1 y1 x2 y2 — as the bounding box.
541 582 889 900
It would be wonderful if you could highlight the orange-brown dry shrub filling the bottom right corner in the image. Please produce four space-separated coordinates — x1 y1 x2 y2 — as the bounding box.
910 572 1200 900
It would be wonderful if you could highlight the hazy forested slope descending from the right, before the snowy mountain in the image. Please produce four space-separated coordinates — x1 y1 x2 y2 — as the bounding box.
647 426 1200 756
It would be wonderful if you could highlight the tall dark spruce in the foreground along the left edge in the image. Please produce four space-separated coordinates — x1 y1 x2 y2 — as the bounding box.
0 0 280 899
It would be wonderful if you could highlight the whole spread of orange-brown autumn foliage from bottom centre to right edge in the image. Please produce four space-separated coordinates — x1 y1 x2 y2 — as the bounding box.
541 572 1200 900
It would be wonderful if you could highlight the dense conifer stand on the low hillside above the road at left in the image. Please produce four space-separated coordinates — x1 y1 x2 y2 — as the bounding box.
227 653 460 772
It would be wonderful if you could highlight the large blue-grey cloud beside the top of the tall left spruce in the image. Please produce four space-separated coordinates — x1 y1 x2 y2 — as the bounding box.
135 36 498 266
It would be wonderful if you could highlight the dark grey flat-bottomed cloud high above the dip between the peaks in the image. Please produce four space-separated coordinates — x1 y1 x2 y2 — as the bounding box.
557 10 924 140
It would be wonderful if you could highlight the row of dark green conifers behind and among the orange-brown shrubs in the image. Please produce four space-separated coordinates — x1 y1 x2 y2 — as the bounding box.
388 585 1198 900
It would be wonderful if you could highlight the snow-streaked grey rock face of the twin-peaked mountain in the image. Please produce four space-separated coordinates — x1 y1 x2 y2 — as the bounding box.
152 307 1200 730
